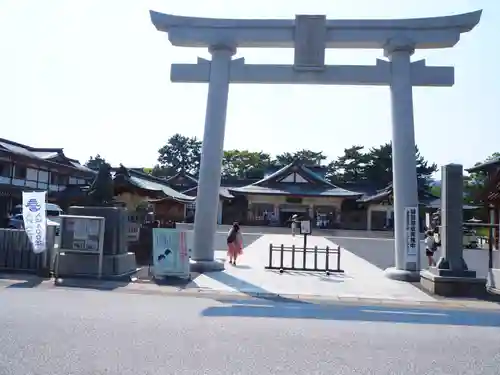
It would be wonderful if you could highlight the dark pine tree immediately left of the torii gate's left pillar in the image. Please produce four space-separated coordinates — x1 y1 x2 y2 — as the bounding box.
158 134 201 175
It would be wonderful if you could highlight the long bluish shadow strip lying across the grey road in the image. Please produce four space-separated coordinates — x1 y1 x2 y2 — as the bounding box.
202 300 500 328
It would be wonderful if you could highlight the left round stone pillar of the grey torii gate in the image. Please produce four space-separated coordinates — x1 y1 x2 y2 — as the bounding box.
191 46 236 272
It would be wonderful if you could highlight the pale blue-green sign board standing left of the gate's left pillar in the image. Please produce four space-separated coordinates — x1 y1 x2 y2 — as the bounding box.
153 228 190 279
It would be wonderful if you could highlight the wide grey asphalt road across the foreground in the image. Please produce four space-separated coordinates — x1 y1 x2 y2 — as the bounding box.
0 288 500 375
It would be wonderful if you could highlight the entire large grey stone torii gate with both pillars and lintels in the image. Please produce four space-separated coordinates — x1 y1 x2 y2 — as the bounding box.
150 11 481 280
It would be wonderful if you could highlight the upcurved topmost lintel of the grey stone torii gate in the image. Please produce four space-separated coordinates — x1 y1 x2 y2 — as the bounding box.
150 10 482 49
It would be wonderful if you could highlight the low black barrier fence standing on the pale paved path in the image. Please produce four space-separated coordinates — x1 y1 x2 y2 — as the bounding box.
266 244 344 275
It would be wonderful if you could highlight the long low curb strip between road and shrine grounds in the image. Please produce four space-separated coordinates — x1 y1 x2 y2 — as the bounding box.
0 277 500 313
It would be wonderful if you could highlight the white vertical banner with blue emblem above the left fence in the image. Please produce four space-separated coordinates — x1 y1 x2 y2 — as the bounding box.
23 191 47 254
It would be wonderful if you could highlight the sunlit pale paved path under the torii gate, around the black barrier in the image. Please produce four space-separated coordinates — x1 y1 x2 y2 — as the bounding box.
183 234 433 301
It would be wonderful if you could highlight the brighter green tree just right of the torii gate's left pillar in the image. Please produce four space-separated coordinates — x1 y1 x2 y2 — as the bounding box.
222 150 271 178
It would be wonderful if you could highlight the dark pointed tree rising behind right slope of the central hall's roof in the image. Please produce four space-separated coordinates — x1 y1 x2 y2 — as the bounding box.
328 145 368 183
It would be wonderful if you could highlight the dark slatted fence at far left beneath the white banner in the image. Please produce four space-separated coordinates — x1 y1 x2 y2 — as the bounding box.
0 229 54 277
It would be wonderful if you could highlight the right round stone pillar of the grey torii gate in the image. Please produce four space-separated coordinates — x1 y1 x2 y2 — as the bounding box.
385 40 420 281
